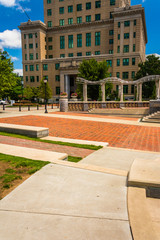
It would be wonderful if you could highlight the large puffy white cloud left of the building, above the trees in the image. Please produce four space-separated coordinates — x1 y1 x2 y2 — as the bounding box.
0 29 21 49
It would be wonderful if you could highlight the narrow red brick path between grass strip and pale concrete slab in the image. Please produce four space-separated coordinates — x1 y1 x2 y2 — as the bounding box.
0 135 94 158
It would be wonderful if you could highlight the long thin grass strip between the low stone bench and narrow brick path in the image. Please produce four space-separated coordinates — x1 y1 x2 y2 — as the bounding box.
0 132 103 150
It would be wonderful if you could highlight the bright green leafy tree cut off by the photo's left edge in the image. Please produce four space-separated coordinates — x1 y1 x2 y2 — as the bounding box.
0 50 18 98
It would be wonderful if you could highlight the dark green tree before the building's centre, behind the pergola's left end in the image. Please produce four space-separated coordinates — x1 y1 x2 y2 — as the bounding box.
77 59 109 100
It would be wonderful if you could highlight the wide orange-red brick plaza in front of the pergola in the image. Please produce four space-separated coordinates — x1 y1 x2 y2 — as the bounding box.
0 116 160 152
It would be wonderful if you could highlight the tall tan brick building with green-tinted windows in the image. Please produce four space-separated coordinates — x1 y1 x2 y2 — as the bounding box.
19 0 147 98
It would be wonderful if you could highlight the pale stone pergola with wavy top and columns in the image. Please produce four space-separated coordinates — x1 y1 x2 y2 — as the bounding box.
77 75 160 102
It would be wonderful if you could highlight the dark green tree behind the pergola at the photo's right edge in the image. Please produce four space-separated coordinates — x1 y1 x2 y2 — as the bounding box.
135 55 160 99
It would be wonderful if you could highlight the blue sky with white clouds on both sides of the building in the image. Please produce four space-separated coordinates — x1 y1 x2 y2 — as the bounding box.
0 0 160 75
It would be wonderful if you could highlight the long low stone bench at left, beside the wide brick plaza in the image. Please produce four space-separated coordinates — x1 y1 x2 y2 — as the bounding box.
0 123 49 138
